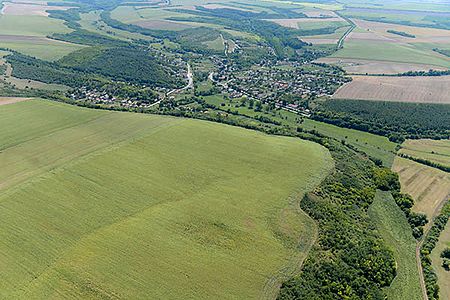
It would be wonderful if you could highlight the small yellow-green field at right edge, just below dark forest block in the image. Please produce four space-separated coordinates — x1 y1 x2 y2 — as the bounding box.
400 139 450 166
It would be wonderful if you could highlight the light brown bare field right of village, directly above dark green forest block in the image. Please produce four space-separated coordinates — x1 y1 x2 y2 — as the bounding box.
333 76 450 104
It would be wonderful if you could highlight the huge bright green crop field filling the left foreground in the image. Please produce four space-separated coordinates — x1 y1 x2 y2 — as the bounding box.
0 100 333 299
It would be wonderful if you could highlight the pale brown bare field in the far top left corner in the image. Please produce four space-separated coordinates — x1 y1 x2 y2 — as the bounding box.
1 2 71 16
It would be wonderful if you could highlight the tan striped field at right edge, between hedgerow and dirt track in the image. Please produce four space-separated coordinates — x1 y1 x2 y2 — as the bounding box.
392 157 450 223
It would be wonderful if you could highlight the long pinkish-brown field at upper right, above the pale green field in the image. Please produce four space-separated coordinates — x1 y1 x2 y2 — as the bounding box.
352 19 450 44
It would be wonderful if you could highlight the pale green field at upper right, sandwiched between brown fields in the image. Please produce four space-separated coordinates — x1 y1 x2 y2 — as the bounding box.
331 40 450 67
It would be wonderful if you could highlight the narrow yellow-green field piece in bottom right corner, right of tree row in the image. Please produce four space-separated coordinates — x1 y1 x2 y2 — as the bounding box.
431 222 450 299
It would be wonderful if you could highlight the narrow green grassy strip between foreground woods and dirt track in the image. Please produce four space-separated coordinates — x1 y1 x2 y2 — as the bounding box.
369 191 421 300
